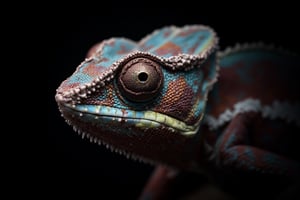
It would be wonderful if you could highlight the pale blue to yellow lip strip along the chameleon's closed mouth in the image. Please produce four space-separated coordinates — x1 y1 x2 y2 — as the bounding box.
64 104 199 135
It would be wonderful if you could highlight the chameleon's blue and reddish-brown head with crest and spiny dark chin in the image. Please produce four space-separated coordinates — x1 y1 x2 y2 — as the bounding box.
56 26 218 169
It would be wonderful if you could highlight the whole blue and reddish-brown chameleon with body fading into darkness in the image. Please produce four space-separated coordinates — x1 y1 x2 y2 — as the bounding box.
55 24 300 199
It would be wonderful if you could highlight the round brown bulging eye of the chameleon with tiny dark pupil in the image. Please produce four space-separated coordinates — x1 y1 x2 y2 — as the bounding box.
118 58 163 102
